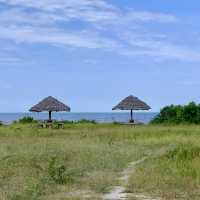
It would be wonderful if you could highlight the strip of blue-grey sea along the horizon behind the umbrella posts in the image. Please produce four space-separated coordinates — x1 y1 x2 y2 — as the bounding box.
0 112 157 124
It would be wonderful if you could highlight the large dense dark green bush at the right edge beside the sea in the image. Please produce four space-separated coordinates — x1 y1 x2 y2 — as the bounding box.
151 102 200 124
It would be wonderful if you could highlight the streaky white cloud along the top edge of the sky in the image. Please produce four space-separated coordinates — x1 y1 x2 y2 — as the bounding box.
0 0 177 24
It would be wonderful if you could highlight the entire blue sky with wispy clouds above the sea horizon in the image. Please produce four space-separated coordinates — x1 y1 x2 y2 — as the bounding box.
0 0 200 112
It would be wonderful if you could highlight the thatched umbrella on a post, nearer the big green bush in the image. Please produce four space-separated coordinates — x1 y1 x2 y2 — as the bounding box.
112 95 151 122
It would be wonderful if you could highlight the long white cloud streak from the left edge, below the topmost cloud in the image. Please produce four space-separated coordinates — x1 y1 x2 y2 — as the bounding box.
0 26 118 49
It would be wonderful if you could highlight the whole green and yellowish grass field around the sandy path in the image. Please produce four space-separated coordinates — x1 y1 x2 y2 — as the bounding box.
0 123 200 200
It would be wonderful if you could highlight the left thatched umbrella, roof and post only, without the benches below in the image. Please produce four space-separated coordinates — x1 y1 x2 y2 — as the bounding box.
30 96 70 122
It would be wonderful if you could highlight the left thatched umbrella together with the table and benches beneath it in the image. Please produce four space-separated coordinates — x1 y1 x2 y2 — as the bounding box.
29 96 71 128
